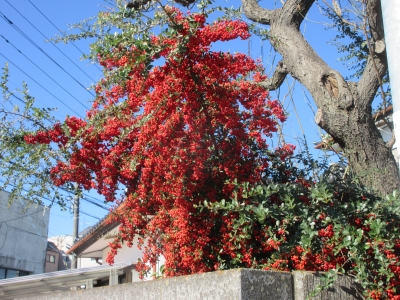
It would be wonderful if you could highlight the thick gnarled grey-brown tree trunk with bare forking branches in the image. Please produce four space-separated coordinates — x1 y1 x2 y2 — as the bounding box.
242 0 400 195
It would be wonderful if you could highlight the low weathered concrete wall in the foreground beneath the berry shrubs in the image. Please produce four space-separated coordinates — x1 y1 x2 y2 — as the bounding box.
23 269 363 300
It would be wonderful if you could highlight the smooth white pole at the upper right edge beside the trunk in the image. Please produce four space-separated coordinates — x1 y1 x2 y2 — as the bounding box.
381 0 400 164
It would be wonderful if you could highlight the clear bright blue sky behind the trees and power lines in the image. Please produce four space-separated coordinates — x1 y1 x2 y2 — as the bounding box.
0 0 350 236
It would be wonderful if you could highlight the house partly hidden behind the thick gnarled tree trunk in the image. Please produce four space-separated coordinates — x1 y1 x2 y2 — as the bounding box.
314 105 400 164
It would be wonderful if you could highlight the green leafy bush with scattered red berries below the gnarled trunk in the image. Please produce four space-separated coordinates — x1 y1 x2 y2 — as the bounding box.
203 159 400 299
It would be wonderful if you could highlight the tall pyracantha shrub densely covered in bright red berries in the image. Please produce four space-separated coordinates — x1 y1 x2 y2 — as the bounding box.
26 8 293 276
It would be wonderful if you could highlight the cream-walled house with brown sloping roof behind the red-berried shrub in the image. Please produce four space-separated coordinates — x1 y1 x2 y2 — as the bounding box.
67 204 163 284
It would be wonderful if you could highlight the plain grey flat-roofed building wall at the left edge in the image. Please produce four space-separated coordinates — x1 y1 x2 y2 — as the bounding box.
0 191 50 274
